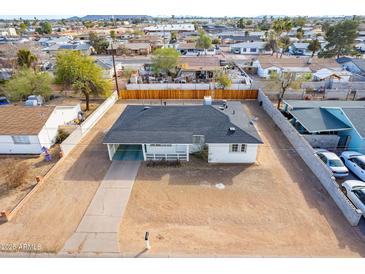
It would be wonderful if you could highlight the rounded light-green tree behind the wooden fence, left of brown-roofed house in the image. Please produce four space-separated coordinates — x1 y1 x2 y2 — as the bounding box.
152 48 180 75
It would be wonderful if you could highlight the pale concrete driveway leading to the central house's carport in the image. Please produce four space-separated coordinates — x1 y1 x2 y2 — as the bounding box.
60 161 140 256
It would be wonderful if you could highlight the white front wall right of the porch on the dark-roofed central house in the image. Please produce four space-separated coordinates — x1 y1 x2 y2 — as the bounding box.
208 144 258 163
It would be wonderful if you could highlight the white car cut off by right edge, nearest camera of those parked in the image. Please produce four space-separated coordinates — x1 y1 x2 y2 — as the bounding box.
341 180 365 216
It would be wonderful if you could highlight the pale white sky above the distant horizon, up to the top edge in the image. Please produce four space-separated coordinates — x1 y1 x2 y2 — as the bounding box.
0 0 365 18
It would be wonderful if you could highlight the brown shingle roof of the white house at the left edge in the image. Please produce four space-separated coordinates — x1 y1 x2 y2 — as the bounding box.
0 106 55 135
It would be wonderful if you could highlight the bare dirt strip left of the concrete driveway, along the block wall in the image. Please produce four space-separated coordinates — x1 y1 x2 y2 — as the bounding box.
0 104 124 255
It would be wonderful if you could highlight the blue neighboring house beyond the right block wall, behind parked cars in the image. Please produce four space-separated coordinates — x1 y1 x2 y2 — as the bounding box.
283 100 365 154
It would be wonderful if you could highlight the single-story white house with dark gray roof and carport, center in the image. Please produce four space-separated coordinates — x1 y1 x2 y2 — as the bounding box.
103 101 263 163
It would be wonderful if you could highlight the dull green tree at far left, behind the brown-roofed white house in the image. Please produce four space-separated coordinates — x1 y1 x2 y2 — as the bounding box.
4 68 52 101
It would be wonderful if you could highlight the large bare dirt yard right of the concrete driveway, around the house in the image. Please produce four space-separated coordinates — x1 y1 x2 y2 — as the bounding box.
119 101 365 257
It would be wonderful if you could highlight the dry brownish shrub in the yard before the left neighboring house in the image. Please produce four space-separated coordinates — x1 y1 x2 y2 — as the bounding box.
5 161 29 190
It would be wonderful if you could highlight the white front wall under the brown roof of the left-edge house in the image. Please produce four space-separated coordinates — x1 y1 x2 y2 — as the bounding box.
0 135 41 154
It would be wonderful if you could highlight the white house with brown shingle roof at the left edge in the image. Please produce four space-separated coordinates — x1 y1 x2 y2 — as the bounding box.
0 105 80 154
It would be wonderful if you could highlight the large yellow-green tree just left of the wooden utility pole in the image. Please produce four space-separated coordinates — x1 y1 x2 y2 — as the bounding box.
55 51 111 110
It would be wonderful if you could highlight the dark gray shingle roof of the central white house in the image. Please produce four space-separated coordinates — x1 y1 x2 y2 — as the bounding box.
103 103 262 144
